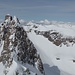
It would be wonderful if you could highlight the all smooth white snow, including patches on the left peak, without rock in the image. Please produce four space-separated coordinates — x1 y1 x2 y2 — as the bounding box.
0 17 75 75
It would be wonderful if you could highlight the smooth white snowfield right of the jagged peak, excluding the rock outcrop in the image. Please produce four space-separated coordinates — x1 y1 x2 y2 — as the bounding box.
24 20 75 75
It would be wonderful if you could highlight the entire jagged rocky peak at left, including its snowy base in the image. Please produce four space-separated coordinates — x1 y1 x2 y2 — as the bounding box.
0 14 45 75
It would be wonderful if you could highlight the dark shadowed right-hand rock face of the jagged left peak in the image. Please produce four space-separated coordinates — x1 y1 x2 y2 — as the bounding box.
15 26 44 73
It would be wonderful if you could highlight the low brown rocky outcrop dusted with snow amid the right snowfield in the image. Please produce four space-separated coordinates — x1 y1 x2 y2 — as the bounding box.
34 30 75 47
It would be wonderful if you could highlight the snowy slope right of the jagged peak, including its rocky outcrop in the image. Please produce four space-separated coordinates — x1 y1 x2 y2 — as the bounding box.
24 20 75 75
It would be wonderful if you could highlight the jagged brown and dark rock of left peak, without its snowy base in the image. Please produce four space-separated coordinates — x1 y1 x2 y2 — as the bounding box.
0 15 45 74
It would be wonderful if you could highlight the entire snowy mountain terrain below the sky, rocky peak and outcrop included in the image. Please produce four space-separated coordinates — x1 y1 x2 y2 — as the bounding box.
0 15 75 75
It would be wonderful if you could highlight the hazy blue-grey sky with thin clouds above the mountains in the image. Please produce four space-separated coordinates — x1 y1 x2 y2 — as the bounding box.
0 0 75 22
